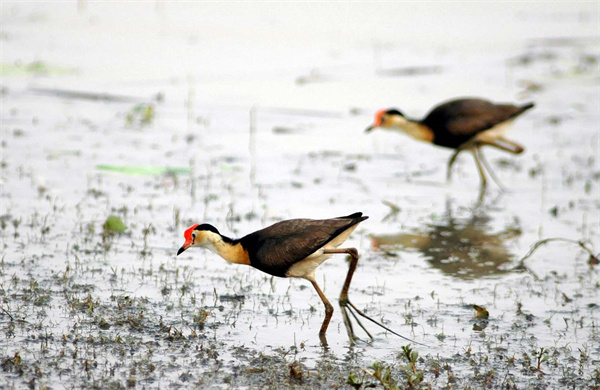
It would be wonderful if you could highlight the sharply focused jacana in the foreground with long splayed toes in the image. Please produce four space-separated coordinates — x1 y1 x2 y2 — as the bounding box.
177 213 414 341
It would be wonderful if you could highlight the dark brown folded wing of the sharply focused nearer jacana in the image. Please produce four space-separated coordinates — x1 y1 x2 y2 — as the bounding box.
240 213 367 276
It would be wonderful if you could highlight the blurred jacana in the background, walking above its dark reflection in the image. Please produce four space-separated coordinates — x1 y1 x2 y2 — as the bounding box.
365 98 533 187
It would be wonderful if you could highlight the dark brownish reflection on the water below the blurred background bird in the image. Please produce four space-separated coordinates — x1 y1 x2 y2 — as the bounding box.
371 200 521 279
